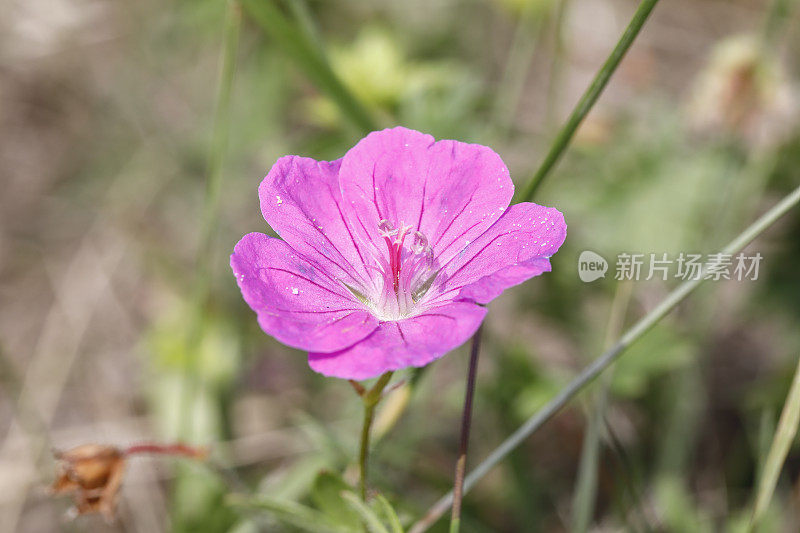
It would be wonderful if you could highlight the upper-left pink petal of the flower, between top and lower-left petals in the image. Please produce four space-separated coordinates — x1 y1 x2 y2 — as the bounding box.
258 156 374 285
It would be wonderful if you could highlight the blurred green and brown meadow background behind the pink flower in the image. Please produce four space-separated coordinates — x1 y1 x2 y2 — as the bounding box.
0 0 800 532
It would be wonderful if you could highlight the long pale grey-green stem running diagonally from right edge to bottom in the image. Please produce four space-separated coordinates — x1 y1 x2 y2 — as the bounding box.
409 181 800 533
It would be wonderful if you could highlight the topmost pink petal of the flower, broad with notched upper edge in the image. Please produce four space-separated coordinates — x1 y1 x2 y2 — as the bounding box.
339 127 514 268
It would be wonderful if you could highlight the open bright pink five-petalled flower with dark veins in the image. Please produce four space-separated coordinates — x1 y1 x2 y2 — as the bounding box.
231 128 566 380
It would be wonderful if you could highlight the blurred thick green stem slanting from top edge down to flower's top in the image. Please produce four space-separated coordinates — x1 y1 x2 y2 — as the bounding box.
242 0 377 133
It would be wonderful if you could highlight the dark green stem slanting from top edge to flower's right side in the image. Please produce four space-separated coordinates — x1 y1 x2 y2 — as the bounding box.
518 0 658 202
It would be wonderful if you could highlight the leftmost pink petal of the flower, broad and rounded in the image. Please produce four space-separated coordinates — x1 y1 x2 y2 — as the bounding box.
231 233 378 352
